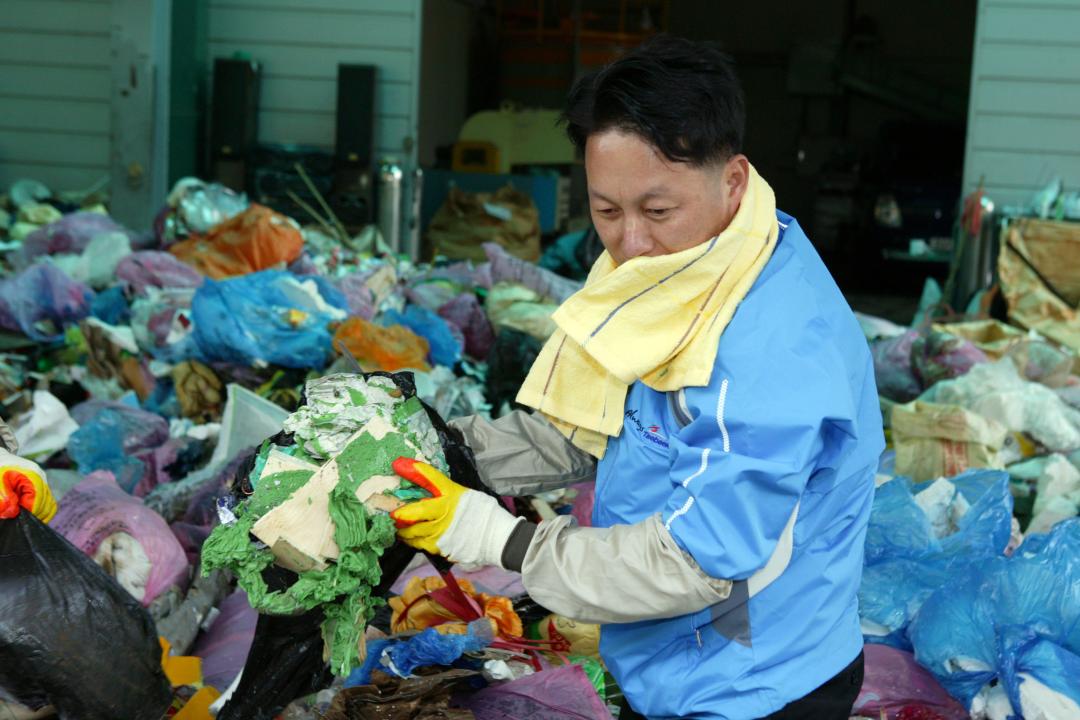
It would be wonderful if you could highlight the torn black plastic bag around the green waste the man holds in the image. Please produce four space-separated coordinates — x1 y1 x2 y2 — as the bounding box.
217 372 494 720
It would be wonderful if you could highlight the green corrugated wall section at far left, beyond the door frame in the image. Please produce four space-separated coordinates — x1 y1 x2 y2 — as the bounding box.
0 0 111 190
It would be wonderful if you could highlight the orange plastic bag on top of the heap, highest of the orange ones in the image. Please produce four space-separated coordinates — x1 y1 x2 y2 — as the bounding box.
168 204 303 280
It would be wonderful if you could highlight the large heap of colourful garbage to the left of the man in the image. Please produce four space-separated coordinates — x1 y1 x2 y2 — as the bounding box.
0 178 618 720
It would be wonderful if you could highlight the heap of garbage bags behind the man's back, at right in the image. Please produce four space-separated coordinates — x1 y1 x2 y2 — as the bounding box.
855 220 1080 720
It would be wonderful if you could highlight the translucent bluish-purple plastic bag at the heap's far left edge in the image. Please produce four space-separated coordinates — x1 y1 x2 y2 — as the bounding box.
0 262 94 342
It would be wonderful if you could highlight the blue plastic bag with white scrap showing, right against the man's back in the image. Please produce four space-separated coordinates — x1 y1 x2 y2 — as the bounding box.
859 470 1012 650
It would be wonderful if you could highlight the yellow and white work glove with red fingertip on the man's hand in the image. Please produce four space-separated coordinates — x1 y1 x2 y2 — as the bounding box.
390 458 525 567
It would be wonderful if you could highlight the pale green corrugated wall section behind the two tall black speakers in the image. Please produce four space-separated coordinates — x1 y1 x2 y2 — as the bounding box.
210 0 421 165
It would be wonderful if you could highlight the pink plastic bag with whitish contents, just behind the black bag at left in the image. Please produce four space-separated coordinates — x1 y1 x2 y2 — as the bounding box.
50 472 188 606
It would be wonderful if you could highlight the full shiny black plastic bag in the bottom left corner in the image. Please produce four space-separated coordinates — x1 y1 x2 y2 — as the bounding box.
0 512 173 720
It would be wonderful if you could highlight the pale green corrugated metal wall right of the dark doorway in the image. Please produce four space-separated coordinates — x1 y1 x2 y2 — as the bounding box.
964 0 1080 204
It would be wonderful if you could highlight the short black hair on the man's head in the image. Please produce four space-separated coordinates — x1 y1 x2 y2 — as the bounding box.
559 35 746 166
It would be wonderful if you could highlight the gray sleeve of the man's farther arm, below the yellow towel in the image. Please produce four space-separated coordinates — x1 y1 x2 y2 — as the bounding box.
450 410 596 497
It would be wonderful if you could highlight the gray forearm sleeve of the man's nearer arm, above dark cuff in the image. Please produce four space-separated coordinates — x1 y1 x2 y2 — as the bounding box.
522 515 731 623
